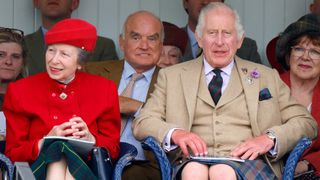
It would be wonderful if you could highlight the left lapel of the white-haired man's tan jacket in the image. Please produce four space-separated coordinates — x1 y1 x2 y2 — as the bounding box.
180 56 203 125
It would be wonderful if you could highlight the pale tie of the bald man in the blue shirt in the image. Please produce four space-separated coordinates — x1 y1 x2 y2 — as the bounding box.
120 73 143 134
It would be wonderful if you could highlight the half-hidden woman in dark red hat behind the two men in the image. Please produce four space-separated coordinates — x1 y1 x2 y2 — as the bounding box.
157 21 188 68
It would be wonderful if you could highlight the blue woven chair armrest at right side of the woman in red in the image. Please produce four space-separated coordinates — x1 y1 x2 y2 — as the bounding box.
113 142 138 180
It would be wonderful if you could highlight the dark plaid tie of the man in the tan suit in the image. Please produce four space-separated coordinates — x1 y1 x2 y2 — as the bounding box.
208 69 223 105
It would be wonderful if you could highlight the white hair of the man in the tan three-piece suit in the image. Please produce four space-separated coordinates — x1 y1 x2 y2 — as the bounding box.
196 2 244 40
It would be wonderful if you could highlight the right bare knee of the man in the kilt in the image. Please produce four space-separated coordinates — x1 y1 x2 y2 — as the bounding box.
209 164 237 180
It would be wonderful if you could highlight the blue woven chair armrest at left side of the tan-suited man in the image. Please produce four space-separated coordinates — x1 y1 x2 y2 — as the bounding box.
142 136 172 180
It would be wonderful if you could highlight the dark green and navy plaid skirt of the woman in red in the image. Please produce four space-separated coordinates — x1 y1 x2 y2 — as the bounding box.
31 141 97 179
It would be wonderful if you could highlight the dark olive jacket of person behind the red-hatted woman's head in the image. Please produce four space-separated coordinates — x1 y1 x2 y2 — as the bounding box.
25 28 118 75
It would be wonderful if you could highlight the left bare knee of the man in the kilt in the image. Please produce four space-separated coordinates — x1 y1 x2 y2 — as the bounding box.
181 162 208 180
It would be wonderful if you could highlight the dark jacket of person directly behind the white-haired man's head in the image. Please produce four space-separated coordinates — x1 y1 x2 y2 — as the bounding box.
182 26 262 64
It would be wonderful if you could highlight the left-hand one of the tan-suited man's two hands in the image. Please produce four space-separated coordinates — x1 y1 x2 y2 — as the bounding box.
171 129 208 157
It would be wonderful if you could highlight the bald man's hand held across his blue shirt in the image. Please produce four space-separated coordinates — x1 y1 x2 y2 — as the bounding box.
119 96 143 115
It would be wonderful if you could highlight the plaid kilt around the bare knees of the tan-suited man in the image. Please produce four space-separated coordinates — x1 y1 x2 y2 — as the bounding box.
173 159 277 180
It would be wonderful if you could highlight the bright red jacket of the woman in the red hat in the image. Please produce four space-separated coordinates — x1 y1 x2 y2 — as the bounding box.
3 72 120 163
